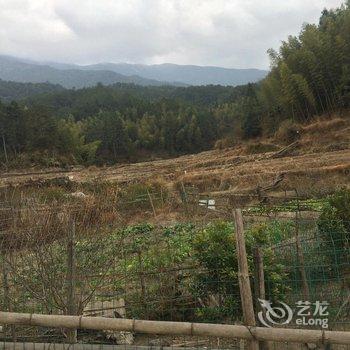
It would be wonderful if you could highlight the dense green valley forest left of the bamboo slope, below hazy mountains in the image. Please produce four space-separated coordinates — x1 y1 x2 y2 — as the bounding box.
0 84 252 165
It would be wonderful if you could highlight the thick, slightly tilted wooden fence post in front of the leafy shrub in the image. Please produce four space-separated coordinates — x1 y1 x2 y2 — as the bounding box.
233 209 259 350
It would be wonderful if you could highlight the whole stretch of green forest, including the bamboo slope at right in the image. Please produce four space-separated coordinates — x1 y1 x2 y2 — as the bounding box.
0 1 350 165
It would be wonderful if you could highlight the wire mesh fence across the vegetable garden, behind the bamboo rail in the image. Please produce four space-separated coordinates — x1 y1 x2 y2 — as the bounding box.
0 185 350 349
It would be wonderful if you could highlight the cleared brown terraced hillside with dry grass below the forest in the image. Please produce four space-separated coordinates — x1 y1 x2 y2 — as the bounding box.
1 118 350 200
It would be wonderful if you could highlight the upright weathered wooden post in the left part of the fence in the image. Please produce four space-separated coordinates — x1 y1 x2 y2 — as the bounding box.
67 220 77 344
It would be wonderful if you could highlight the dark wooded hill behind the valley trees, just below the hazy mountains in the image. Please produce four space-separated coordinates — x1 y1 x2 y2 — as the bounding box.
22 84 247 120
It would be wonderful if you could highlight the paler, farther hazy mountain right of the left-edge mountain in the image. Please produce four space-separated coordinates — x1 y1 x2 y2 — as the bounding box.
82 63 268 86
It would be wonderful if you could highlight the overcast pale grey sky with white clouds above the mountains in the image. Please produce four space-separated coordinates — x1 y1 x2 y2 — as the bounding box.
0 0 342 69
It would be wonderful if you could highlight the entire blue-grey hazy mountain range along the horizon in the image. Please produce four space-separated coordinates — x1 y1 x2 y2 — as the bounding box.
0 56 268 88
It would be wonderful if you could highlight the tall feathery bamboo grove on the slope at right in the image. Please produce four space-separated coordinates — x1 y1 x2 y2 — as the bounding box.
260 2 350 121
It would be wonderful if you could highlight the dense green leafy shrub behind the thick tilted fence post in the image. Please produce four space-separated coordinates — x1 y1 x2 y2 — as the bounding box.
192 221 286 322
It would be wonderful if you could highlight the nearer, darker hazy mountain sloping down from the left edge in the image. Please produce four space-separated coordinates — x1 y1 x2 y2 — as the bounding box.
0 56 174 88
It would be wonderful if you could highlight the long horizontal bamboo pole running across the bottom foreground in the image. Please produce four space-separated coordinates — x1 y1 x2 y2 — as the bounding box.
0 312 350 345
